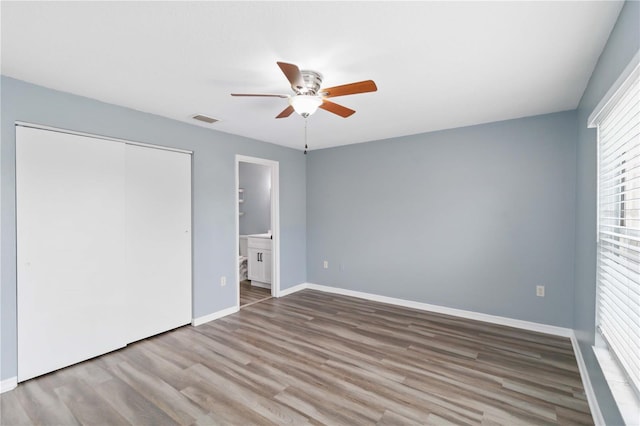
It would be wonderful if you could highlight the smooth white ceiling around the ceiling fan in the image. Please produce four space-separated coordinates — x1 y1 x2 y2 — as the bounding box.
1 1 622 149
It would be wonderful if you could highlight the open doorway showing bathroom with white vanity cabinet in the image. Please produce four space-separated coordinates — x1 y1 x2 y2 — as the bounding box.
236 155 280 308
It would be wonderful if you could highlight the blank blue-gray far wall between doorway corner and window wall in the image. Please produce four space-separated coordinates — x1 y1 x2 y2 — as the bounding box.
307 112 577 327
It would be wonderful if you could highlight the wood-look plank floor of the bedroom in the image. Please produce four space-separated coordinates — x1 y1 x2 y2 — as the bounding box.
0 290 593 425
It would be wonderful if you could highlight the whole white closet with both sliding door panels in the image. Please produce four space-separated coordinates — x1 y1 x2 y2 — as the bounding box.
16 125 191 381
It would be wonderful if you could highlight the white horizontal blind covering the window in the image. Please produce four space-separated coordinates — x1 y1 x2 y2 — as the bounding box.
596 65 640 398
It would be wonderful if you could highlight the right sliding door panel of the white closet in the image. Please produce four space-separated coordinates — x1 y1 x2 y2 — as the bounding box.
126 145 191 341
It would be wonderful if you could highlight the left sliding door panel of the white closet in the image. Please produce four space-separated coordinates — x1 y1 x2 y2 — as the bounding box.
16 126 126 381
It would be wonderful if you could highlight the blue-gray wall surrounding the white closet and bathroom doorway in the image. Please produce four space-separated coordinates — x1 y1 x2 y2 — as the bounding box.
0 76 306 379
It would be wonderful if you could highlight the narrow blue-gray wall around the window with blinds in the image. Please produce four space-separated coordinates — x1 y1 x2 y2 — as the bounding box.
573 1 640 425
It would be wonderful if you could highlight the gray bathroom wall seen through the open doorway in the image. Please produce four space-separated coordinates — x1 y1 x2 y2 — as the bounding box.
238 162 271 235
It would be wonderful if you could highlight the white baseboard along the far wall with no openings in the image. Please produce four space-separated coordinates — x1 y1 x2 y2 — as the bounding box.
305 283 574 337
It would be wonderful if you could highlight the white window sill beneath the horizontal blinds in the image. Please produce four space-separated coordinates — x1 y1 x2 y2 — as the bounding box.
593 346 640 425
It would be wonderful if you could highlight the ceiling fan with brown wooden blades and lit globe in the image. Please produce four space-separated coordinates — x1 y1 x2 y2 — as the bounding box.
231 62 378 118
